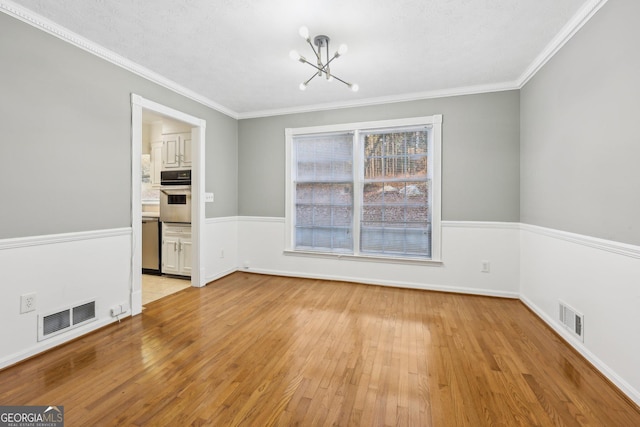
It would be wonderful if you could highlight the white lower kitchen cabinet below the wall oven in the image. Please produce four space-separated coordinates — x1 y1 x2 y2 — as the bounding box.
162 222 191 276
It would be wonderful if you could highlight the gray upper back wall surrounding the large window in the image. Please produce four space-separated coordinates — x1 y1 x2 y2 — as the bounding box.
238 91 520 222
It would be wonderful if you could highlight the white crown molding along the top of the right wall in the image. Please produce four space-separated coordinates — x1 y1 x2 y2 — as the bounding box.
517 0 608 89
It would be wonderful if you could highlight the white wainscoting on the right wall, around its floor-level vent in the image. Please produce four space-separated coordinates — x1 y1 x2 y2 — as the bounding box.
520 224 640 405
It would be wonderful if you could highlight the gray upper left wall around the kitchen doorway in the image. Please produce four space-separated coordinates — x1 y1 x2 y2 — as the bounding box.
0 13 237 238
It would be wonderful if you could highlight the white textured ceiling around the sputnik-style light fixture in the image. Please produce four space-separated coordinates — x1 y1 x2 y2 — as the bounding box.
8 0 589 116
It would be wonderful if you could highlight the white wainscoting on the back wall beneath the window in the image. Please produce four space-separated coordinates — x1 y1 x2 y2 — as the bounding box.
238 217 519 298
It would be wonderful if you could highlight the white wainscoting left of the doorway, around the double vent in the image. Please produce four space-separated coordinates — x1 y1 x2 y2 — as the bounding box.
0 228 131 368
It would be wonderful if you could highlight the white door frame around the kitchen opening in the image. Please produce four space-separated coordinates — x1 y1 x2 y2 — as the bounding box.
131 93 207 316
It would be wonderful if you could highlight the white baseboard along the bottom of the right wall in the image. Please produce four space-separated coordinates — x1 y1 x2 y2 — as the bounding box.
519 294 640 404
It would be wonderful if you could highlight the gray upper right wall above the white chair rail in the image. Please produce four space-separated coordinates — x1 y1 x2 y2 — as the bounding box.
520 0 640 245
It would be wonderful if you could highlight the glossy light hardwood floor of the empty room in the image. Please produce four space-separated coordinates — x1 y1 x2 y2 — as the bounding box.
0 273 640 427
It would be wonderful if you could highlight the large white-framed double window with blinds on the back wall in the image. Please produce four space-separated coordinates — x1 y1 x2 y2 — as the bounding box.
286 116 442 260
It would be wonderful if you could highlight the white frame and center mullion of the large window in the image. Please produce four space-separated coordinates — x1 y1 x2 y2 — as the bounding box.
284 114 442 264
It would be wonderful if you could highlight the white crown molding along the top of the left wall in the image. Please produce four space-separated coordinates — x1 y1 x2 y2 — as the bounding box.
0 0 238 119
